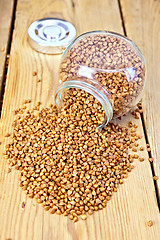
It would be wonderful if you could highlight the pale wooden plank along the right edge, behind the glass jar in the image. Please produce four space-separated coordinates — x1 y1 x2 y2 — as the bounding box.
121 0 160 200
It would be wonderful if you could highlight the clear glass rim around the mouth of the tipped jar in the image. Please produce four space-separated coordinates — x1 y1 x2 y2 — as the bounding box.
55 77 113 129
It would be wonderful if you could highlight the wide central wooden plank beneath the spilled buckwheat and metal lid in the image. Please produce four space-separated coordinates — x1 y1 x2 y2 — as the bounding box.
0 0 160 240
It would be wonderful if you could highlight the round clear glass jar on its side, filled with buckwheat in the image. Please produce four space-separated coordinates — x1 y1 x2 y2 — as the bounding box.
55 31 145 128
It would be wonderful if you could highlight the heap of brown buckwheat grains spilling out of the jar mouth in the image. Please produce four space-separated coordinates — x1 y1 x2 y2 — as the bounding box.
4 89 144 222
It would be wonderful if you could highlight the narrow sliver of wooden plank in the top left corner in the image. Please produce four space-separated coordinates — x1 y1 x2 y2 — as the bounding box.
0 0 14 96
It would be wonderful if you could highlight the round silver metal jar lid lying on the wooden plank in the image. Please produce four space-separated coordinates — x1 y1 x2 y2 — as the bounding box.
28 18 76 54
